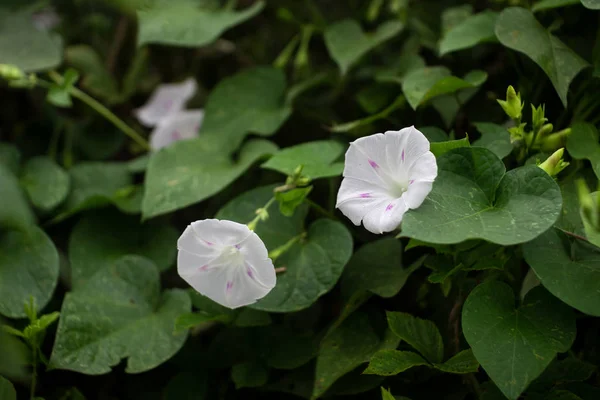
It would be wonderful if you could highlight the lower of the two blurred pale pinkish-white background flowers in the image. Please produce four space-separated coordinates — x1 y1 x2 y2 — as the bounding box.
150 110 204 150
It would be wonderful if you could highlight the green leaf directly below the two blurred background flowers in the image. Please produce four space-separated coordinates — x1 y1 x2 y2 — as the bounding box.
142 138 277 222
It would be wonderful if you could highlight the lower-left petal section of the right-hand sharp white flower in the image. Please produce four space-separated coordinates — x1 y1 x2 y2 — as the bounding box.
336 178 393 226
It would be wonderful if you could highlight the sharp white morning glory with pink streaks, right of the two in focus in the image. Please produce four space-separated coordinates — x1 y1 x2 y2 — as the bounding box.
336 126 437 233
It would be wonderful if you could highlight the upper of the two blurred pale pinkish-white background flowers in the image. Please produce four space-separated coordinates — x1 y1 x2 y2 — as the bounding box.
134 78 197 126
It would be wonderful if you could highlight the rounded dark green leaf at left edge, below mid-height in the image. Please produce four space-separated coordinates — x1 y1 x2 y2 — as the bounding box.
0 226 59 318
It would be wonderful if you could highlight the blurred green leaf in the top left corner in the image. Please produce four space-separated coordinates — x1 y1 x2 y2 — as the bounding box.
0 8 62 72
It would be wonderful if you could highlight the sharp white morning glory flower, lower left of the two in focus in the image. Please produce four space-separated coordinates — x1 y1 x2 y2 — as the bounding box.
177 219 276 308
